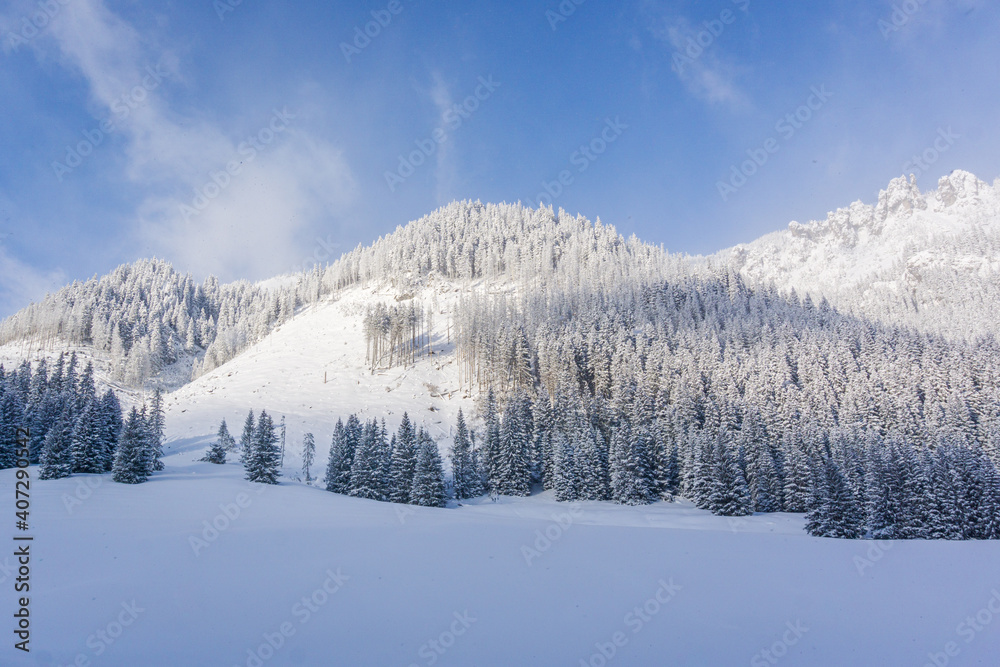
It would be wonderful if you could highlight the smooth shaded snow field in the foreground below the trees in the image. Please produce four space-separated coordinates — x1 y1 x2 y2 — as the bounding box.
0 460 1000 667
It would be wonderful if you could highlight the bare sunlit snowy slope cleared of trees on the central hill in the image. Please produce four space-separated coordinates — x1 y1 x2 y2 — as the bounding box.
165 280 474 474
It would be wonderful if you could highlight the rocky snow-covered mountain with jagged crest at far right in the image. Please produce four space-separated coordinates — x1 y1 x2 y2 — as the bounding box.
710 171 1000 337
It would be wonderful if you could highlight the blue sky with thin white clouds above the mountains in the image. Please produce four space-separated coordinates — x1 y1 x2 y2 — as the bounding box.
0 0 1000 315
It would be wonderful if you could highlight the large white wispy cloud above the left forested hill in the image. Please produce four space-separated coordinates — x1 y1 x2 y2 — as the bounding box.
9 0 355 278
